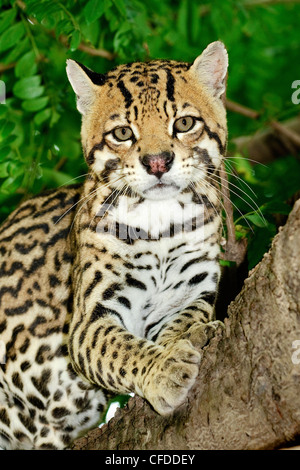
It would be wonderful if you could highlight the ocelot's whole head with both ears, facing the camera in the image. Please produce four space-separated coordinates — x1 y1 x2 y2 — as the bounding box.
67 42 228 200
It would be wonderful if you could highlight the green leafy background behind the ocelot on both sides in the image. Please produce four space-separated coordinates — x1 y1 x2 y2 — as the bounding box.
0 0 300 268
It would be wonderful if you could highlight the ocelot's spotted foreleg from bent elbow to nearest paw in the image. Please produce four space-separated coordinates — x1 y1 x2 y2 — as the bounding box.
69 310 201 415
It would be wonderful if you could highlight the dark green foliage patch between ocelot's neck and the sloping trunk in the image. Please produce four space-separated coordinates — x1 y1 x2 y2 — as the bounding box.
226 155 300 269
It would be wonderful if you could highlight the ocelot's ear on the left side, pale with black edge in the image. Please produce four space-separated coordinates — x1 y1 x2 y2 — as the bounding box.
67 59 106 114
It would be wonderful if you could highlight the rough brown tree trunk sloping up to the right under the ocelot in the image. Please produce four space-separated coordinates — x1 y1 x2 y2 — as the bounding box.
73 201 300 450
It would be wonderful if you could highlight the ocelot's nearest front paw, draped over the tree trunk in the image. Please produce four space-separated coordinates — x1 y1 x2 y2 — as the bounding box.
145 340 201 416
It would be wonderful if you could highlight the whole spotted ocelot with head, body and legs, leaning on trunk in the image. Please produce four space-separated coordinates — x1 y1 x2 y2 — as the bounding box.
0 42 227 449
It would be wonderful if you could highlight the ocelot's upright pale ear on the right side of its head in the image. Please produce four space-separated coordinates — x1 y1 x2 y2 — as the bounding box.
191 41 228 98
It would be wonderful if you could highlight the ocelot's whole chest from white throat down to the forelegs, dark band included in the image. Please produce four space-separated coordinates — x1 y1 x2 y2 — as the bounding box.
77 194 219 337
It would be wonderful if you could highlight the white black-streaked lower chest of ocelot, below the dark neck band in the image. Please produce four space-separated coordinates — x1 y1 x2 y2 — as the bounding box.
104 231 218 337
